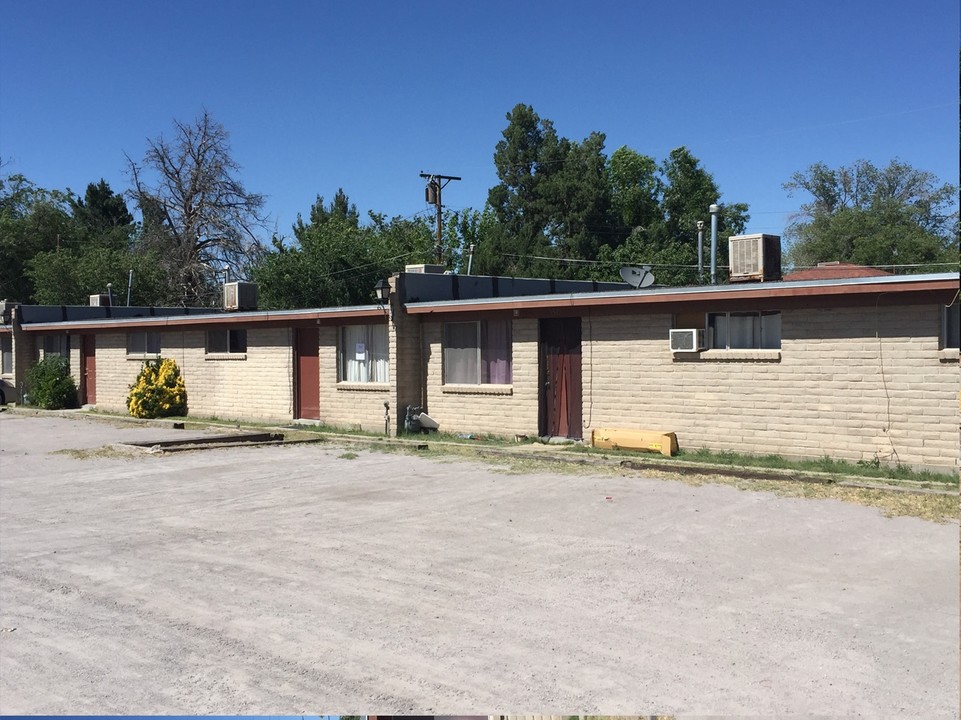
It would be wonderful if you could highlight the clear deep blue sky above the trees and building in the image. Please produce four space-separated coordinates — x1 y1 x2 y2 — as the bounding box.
0 0 961 242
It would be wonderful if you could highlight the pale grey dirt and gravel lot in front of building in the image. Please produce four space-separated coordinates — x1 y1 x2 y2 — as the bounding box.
0 413 959 718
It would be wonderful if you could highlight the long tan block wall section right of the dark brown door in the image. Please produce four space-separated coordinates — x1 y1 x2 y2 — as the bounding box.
583 305 959 469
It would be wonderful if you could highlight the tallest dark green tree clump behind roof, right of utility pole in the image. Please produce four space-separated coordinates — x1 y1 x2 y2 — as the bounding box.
475 104 748 284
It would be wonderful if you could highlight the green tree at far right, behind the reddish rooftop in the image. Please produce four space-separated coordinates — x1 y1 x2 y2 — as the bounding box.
784 159 959 272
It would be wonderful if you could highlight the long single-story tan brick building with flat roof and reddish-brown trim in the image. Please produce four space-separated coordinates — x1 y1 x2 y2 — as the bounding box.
0 252 961 470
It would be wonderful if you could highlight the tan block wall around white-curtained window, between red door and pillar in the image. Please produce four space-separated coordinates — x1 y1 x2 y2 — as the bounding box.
319 319 395 432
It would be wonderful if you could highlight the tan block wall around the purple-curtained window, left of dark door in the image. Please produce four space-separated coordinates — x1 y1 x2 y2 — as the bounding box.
424 319 538 436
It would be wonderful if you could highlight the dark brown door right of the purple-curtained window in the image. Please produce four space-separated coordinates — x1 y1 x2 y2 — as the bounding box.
540 318 583 438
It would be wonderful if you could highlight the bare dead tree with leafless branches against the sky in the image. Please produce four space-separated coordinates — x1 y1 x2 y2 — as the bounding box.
127 110 266 305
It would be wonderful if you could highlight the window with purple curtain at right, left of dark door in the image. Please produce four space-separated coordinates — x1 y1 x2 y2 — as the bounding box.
444 320 512 385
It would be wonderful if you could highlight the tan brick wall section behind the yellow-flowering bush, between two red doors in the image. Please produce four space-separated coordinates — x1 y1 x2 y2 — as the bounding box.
97 328 293 421
